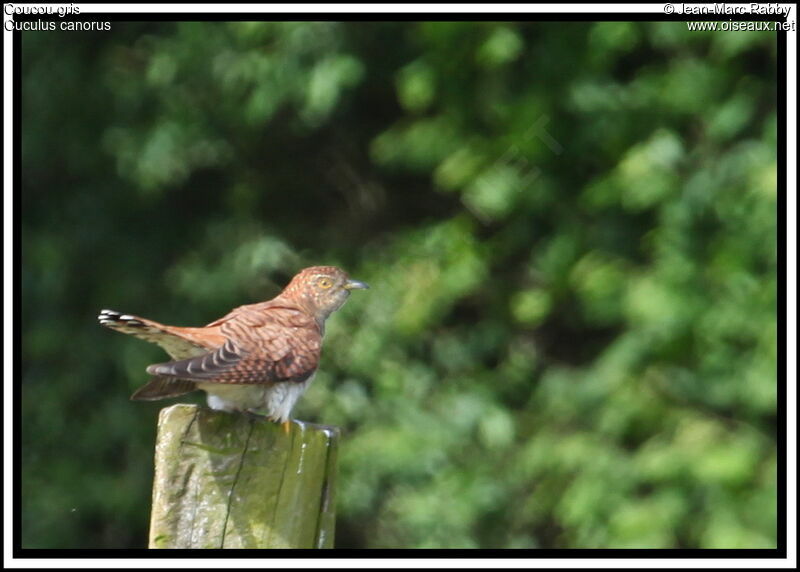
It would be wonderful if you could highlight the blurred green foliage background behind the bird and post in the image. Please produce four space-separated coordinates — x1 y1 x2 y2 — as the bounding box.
22 22 777 548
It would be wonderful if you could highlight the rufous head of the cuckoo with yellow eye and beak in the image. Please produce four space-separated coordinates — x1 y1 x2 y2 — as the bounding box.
282 266 369 323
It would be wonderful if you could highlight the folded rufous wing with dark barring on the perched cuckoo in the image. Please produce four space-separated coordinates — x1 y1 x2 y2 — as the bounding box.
147 308 321 384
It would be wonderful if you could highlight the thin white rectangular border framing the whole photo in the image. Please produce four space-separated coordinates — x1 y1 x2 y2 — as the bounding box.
3 2 797 569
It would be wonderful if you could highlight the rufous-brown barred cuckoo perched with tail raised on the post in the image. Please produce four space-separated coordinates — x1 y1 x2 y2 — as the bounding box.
97 266 369 432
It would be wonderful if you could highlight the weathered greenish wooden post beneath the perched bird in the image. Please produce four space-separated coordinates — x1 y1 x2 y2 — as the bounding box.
150 404 339 548
